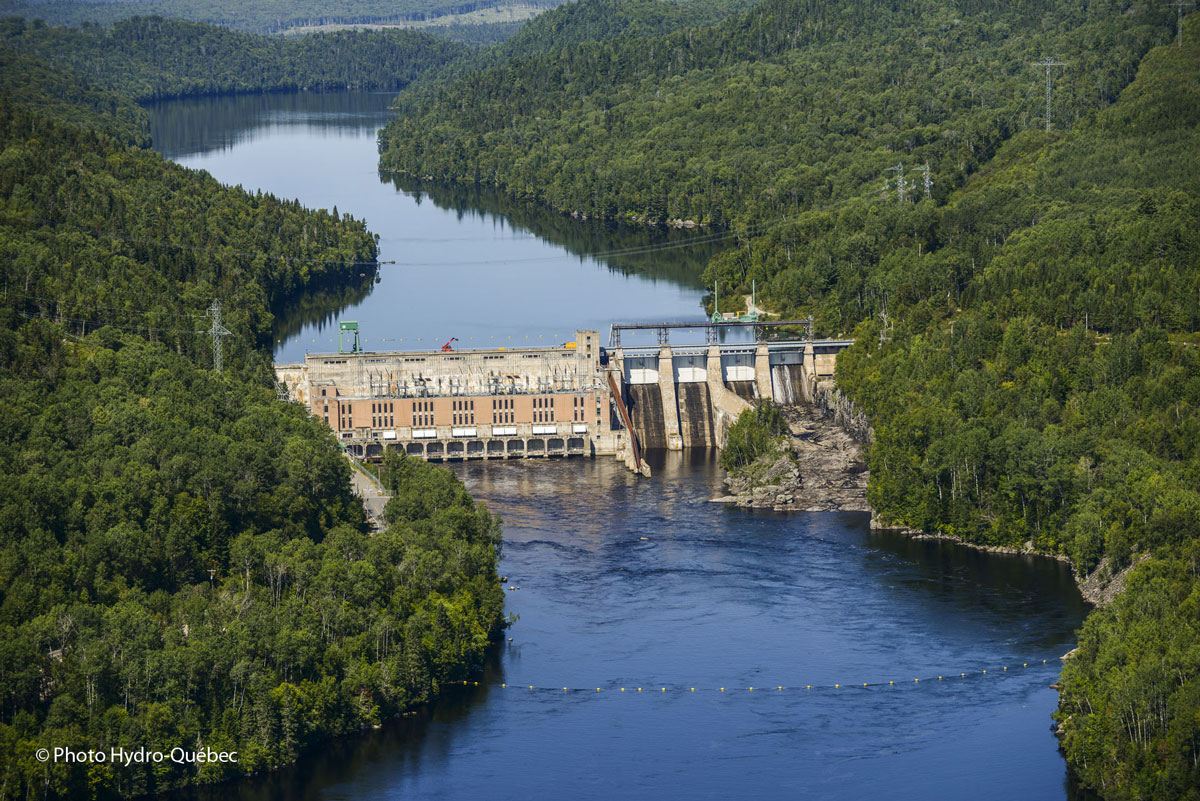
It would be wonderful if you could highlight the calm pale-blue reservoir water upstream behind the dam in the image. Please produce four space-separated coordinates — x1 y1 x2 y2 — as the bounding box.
150 92 729 362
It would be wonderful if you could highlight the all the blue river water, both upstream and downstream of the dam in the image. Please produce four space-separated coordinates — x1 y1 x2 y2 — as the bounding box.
145 95 1086 801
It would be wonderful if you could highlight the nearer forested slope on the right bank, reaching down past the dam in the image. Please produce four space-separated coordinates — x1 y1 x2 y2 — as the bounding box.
825 31 1200 799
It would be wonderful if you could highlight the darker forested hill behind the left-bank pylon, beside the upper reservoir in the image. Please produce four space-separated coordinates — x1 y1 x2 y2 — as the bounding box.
0 73 376 359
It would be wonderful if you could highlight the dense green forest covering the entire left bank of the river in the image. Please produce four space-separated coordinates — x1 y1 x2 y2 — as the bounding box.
0 35 503 799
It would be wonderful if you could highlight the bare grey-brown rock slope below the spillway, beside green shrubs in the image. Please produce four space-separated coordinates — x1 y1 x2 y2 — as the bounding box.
713 406 870 512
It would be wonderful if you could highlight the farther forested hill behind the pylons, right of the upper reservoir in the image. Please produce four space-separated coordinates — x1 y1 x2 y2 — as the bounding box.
380 0 1170 225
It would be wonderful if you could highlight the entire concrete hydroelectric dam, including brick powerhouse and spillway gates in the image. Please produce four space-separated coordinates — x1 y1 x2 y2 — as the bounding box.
275 320 853 475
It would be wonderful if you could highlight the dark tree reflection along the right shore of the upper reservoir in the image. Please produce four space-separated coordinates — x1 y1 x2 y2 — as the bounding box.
379 173 725 289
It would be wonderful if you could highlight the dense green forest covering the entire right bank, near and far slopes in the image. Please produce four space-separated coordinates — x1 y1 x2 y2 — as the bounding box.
382 0 1200 799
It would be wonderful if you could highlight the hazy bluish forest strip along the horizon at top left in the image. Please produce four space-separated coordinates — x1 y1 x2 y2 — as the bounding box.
2 0 556 34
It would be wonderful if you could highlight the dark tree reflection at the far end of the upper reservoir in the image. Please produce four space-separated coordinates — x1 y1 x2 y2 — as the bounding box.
145 91 392 158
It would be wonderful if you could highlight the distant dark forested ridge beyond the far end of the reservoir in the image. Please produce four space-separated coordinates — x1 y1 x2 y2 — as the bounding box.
0 17 472 101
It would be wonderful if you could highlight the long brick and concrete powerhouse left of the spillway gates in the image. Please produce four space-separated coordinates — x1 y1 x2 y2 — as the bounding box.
275 331 625 460
